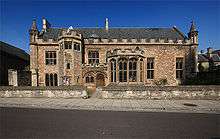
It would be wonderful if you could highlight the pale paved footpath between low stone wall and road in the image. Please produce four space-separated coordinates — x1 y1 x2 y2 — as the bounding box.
0 98 220 114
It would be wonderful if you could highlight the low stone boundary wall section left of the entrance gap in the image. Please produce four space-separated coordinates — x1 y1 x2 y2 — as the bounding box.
0 86 87 98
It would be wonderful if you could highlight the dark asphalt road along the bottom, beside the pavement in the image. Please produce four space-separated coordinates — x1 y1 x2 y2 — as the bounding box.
0 108 220 139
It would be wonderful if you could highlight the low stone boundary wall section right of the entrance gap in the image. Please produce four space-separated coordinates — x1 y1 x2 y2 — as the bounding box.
97 85 220 100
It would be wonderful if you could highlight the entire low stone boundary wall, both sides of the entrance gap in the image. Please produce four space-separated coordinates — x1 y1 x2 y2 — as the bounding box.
0 85 220 100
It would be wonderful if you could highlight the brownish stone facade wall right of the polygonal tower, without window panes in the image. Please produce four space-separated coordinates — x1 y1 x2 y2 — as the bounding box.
85 43 196 86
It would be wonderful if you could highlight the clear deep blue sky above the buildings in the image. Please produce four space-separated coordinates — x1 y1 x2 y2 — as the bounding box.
0 0 220 52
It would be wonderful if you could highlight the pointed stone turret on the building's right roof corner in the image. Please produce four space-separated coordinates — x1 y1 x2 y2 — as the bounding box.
188 21 198 44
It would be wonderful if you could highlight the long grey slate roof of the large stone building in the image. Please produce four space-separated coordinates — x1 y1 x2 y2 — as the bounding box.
39 27 186 40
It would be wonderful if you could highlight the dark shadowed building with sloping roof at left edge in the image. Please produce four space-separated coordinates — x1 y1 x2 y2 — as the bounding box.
0 41 31 86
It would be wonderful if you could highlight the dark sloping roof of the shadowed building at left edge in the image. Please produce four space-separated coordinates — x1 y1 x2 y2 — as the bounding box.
0 41 30 61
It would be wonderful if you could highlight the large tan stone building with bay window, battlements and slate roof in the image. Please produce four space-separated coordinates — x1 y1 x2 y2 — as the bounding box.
29 19 198 87
